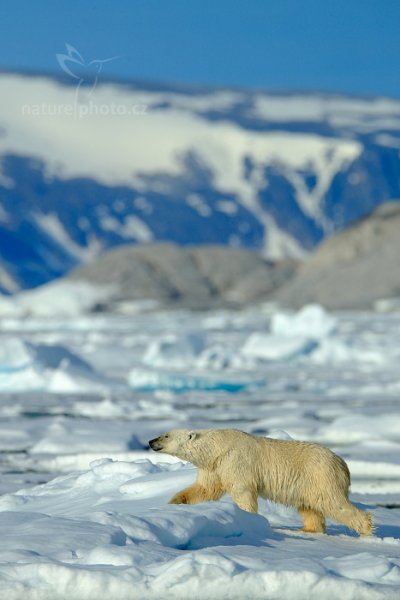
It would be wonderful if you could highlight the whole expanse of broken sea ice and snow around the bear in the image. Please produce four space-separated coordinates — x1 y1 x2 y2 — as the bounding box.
0 307 400 600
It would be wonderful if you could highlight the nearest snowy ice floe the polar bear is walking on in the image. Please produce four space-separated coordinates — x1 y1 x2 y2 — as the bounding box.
0 459 400 600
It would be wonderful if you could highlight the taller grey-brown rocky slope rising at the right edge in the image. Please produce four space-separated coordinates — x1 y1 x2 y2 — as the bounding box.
273 202 400 309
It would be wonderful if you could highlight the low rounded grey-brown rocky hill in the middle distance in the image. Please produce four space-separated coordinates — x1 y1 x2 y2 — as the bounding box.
65 243 297 311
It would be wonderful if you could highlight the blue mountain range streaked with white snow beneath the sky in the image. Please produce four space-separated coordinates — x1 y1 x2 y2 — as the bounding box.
0 73 400 292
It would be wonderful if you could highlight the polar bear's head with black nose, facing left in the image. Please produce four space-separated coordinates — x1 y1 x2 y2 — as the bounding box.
149 429 206 465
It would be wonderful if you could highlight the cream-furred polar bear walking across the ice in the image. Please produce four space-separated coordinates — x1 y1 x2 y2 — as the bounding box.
149 429 373 535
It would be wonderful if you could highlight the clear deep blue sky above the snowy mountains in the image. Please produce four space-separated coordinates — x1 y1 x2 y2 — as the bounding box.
0 0 400 97
